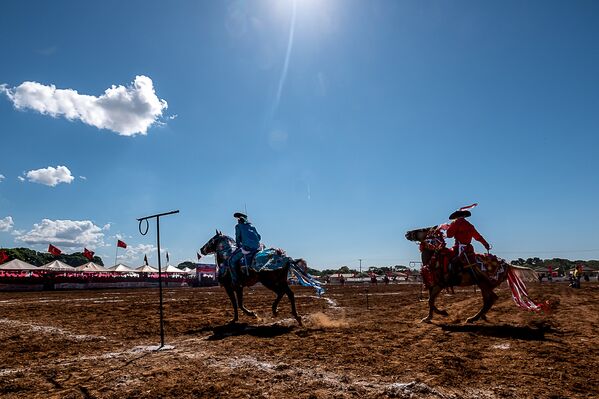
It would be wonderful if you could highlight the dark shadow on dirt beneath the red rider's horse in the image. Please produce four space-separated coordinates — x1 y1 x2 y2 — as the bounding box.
437 323 557 341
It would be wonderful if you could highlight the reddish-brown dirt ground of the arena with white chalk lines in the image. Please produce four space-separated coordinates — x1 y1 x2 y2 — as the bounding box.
0 283 599 399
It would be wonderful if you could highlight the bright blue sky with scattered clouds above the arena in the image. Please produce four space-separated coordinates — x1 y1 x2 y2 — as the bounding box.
0 0 599 268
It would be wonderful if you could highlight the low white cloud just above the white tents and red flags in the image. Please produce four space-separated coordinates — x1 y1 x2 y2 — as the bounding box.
16 219 104 247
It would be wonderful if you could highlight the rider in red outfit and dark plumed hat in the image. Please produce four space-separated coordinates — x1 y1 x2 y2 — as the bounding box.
447 210 491 276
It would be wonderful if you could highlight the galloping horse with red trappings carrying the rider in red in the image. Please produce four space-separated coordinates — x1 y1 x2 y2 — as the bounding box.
406 226 541 323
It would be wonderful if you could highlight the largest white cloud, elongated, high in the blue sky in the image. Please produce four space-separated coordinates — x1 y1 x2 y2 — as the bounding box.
0 76 168 136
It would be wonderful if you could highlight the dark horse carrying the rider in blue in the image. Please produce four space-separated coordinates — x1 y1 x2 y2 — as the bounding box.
200 230 305 325
